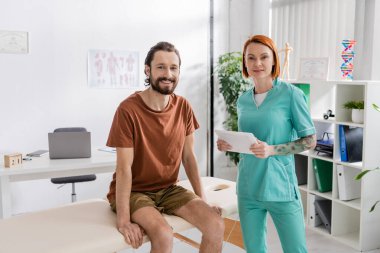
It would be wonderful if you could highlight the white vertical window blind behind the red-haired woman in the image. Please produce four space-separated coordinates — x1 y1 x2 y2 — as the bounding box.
270 0 355 79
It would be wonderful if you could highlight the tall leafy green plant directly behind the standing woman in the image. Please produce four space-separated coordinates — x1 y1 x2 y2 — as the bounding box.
215 52 252 164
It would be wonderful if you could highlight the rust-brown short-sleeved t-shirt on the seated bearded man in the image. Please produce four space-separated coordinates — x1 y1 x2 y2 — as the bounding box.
107 92 199 202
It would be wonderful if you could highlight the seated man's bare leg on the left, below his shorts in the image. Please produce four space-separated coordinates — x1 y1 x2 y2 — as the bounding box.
132 207 173 253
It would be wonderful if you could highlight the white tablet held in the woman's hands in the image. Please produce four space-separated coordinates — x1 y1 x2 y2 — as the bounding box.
215 130 257 155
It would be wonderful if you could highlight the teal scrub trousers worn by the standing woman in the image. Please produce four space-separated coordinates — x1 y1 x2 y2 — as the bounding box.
238 196 307 253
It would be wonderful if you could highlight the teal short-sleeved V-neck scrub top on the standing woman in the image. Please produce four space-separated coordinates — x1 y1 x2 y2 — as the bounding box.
237 79 315 201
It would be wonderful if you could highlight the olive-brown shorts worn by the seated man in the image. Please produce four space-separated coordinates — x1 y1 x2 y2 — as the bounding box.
111 185 198 215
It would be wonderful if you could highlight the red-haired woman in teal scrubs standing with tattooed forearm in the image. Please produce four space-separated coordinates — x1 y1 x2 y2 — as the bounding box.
217 35 316 253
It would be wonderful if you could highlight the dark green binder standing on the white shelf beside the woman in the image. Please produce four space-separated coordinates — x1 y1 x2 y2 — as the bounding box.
313 159 333 192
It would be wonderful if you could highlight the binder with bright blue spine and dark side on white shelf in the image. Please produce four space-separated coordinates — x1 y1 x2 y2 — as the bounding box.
339 125 363 162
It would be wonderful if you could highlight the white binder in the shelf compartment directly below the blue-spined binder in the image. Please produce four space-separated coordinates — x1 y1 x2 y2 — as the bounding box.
336 165 361 200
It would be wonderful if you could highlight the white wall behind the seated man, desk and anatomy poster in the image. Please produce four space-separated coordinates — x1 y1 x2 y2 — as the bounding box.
0 0 209 213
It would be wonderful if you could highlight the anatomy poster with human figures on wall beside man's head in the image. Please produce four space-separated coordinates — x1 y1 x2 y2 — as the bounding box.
88 50 143 89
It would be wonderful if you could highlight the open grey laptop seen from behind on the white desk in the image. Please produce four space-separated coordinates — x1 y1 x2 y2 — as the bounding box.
48 127 91 159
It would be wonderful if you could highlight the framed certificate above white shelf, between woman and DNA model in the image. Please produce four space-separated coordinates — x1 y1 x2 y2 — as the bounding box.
298 57 329 80
